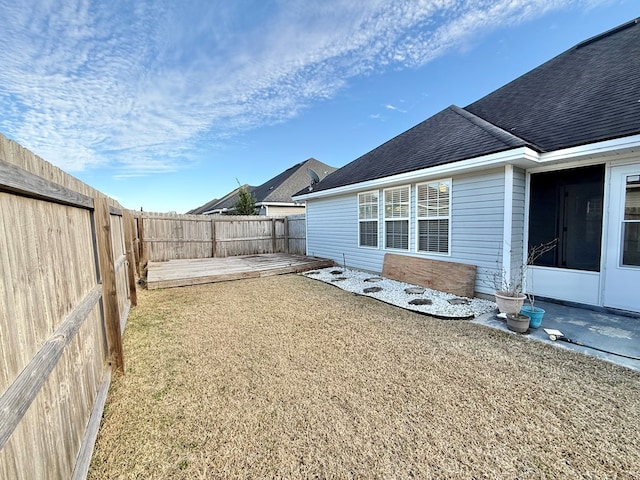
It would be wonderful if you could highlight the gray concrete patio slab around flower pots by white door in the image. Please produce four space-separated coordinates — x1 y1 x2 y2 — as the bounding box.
473 300 640 371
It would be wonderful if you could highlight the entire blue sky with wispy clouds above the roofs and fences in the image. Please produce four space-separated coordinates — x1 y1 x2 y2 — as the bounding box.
0 0 640 213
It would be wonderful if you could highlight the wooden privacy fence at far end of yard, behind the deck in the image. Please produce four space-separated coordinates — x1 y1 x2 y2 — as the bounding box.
134 212 306 263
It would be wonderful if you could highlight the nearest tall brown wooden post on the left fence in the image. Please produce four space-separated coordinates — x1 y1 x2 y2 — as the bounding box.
94 197 124 373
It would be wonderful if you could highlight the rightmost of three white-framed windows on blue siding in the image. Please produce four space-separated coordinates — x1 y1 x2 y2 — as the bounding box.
417 180 451 254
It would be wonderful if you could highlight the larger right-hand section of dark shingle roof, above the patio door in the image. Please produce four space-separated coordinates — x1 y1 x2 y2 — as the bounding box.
466 20 640 151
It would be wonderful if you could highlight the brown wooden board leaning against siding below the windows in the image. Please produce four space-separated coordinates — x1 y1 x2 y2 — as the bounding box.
382 253 476 298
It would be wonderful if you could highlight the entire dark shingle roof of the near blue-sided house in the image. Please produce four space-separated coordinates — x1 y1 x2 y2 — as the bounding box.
298 19 640 195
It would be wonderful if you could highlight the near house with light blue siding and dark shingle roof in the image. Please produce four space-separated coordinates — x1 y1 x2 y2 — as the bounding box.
294 20 640 312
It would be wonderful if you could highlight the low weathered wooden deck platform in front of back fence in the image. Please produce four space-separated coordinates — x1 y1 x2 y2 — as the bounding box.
147 253 335 290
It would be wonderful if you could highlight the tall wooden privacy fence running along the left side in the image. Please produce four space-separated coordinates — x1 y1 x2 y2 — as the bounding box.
0 135 136 478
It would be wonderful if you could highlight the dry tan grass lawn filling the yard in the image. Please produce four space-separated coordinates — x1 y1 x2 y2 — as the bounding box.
89 275 640 479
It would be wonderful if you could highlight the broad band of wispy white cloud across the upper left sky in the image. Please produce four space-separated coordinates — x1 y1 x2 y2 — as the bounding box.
0 0 604 177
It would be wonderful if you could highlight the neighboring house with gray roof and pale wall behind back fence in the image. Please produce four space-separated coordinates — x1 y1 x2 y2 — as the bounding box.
188 158 336 217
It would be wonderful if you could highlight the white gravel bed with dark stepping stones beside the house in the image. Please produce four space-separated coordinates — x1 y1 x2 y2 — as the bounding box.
303 267 496 320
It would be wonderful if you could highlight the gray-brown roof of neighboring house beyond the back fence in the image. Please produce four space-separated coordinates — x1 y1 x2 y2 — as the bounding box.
202 158 336 213
